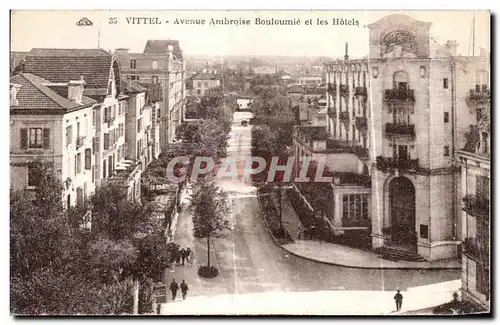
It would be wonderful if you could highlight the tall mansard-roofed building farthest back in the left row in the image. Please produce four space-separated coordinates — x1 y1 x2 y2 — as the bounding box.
115 40 186 151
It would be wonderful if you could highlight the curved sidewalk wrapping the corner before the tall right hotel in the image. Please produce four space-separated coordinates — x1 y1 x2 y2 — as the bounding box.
276 194 461 269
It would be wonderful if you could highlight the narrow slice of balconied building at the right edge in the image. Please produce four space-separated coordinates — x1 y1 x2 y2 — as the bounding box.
457 83 491 310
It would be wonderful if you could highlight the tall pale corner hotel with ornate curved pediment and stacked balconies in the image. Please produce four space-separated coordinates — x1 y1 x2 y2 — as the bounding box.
296 15 489 260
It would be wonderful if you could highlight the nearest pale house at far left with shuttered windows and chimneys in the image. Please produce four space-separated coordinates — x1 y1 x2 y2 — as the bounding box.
10 73 96 207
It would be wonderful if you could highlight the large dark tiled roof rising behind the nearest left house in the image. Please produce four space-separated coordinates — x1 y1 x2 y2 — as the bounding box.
24 49 113 89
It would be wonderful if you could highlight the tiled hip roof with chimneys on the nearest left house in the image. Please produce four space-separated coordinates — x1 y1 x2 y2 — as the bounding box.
10 73 96 110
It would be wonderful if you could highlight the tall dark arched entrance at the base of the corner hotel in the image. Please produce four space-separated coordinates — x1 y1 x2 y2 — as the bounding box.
389 177 417 250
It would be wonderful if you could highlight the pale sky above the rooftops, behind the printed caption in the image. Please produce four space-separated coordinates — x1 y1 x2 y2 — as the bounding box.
11 10 490 58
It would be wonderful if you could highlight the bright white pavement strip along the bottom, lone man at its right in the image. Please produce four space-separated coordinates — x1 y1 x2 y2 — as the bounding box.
160 280 460 316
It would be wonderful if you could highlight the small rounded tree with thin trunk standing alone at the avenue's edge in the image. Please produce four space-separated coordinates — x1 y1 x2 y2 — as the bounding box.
190 180 230 267
